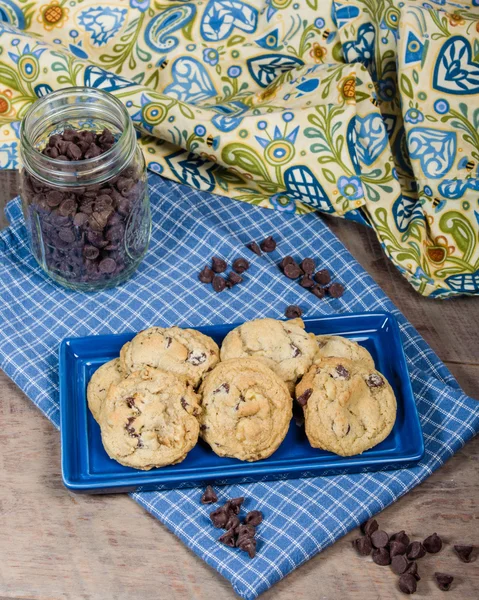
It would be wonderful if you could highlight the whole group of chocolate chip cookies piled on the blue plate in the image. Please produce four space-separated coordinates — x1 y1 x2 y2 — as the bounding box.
87 319 396 469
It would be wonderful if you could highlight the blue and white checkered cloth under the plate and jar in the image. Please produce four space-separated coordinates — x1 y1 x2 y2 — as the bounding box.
0 175 479 600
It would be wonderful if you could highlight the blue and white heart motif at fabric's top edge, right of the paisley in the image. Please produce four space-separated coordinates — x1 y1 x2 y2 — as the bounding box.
200 0 258 42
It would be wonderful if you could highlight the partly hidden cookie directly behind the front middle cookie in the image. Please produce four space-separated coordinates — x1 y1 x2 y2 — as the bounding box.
221 319 317 392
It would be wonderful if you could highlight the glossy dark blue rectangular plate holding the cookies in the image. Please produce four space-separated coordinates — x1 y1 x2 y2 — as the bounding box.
60 313 424 493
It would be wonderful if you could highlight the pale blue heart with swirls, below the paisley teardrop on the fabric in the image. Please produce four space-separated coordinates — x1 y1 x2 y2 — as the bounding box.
164 56 217 104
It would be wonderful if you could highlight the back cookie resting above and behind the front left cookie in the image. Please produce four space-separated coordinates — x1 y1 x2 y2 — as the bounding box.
120 327 219 387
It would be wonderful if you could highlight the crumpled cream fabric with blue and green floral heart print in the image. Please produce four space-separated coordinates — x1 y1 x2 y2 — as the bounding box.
0 0 479 298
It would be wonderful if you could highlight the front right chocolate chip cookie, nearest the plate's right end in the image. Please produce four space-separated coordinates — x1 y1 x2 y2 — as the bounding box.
296 358 396 456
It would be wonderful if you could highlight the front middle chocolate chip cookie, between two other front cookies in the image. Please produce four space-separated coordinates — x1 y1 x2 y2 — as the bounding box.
200 358 292 461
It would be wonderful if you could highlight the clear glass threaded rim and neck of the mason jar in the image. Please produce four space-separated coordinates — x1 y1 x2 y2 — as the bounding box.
20 86 136 187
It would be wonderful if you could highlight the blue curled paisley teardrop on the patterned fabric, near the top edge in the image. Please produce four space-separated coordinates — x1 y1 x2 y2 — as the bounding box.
145 3 196 54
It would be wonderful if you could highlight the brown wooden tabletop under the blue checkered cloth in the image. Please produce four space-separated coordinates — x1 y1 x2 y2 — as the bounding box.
0 170 479 600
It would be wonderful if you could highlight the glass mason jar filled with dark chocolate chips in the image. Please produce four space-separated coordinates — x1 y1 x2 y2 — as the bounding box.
20 87 151 291
